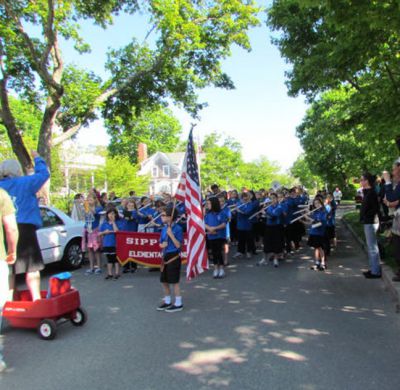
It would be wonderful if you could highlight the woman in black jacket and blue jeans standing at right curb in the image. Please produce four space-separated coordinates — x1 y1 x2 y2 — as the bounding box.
360 173 381 279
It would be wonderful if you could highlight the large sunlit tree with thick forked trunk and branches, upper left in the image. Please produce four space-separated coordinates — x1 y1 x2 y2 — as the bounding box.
0 0 259 167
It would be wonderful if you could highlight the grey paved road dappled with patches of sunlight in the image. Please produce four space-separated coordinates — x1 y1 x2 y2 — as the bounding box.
0 210 400 390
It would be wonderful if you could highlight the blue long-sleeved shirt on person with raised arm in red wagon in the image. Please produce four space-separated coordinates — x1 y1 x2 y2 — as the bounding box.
0 157 50 228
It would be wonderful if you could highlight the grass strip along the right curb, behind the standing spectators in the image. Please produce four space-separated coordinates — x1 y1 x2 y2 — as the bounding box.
342 211 400 313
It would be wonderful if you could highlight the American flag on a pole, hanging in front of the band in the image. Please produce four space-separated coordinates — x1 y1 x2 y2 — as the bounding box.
175 129 208 280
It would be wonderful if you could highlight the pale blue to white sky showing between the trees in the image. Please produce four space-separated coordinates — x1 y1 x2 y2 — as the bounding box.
69 3 307 171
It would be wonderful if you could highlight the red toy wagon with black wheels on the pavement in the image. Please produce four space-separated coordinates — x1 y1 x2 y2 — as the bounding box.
3 288 87 340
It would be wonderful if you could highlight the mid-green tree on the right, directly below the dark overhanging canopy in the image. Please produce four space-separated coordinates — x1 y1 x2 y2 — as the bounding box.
297 87 398 187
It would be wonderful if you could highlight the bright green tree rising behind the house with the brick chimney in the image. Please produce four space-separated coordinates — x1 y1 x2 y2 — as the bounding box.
106 107 182 164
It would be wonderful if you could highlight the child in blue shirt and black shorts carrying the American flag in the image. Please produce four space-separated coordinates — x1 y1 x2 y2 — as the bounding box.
157 204 183 313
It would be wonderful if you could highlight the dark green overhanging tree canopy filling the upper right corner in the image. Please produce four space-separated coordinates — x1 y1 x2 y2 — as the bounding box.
268 0 400 143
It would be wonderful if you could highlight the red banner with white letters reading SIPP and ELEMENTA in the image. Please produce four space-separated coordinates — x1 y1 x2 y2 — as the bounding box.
116 231 187 268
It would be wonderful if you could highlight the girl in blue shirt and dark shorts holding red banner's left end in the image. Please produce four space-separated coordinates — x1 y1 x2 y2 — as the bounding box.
99 209 122 280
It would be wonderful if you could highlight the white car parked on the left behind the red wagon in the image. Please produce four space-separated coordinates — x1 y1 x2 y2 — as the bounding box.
36 206 84 269
